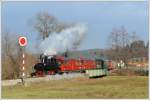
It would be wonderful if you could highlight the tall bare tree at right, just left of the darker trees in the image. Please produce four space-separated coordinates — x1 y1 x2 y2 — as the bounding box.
108 26 129 62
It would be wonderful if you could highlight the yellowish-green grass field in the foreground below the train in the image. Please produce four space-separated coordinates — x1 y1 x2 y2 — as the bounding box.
2 76 148 99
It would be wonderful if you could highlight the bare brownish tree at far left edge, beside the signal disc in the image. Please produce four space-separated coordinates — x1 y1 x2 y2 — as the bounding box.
2 32 22 79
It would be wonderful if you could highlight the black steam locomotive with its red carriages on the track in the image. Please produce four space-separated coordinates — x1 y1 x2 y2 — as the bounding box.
31 54 112 77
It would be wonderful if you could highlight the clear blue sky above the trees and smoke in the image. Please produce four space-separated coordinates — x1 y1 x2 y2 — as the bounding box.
2 1 148 50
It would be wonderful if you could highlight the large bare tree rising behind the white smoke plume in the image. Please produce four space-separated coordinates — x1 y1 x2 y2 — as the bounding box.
32 12 69 40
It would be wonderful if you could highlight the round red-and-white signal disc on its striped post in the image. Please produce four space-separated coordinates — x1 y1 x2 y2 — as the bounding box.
18 36 27 84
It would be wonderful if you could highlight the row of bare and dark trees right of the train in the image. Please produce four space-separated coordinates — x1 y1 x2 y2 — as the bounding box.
106 26 149 65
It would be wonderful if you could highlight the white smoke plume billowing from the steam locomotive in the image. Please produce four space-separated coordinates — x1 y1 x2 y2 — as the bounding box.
40 24 87 55
